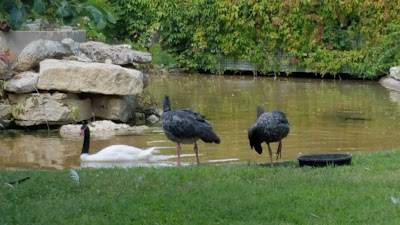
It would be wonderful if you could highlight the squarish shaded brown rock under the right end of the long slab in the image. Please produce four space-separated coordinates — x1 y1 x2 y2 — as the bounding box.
91 95 135 122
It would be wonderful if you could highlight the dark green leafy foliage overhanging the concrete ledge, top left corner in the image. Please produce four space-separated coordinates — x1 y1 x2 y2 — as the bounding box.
0 0 116 40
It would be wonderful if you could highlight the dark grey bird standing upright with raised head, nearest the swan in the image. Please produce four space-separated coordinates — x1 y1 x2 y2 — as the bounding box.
161 96 221 166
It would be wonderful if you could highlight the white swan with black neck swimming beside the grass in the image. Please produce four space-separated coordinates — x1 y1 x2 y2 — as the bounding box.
80 124 158 162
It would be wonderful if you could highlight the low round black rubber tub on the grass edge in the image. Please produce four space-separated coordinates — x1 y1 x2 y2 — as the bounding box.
297 153 353 167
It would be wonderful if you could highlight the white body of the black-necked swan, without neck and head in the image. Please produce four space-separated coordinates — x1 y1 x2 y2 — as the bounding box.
81 145 156 162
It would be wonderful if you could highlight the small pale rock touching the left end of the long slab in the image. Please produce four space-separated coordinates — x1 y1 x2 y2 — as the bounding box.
5 71 39 93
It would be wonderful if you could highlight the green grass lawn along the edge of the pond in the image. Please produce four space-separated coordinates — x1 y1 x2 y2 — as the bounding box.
0 151 400 225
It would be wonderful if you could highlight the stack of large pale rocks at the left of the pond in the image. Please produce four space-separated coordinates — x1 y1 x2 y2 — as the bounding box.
0 38 151 127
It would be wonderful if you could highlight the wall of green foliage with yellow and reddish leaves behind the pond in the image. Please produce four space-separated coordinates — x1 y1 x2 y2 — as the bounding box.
111 0 400 78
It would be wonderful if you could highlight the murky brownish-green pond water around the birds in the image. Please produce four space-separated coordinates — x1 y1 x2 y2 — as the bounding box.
0 74 400 169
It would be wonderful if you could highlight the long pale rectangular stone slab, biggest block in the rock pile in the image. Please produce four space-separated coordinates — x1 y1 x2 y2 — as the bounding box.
37 59 144 95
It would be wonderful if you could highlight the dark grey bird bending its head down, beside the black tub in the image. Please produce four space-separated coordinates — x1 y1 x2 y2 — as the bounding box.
248 106 290 166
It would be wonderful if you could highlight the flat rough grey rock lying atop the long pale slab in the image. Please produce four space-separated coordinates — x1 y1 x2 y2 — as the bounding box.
79 41 151 65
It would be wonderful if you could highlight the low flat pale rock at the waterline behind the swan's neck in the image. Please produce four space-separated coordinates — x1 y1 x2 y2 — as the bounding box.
60 120 151 137
